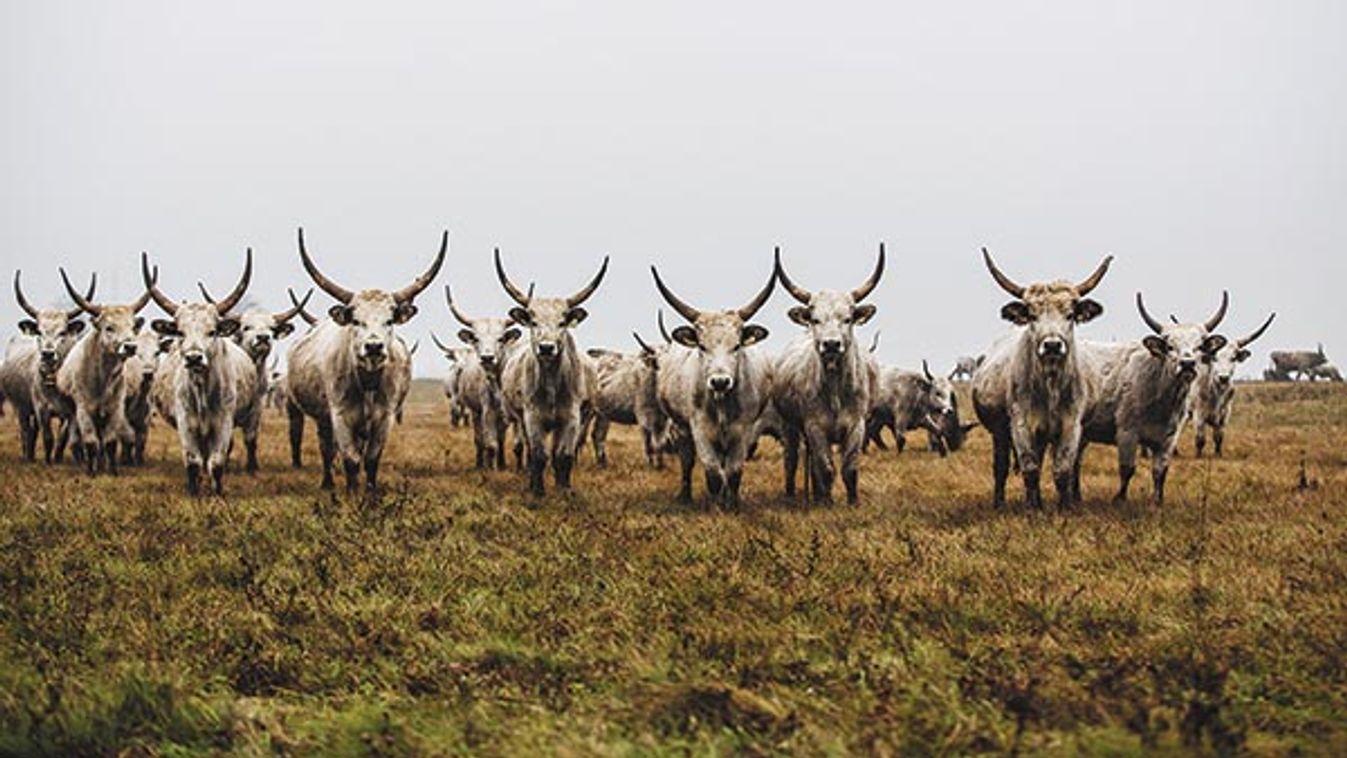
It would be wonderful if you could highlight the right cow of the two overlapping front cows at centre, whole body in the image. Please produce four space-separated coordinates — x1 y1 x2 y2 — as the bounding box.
772 242 884 504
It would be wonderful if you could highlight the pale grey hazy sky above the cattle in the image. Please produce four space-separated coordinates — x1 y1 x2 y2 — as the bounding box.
0 0 1347 373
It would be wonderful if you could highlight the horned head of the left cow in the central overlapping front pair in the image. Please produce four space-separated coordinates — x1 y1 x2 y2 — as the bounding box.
651 265 777 399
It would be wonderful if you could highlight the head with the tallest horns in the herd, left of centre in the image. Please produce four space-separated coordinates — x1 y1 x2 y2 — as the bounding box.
299 229 449 372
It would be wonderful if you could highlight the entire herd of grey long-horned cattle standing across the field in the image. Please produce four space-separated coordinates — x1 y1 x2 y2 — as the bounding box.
0 230 1336 508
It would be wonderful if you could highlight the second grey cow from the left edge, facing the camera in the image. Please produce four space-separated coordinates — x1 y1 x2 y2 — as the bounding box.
57 269 154 474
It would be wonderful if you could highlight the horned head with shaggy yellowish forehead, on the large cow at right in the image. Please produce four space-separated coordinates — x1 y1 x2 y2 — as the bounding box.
982 248 1113 372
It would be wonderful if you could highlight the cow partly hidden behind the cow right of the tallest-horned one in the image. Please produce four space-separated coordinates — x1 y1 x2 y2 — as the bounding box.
435 284 520 469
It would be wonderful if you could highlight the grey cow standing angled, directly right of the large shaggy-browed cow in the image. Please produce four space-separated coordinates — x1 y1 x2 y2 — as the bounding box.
1072 292 1230 505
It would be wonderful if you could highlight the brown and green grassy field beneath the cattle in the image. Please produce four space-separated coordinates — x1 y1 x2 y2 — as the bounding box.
0 384 1347 755
